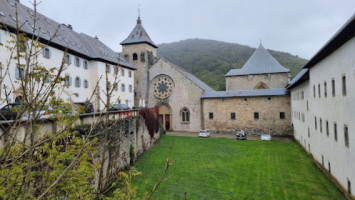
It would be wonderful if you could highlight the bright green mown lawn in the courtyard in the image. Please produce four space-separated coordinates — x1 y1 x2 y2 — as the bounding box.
133 136 345 200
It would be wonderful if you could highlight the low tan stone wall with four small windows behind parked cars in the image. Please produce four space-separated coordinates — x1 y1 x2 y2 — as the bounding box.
202 95 292 136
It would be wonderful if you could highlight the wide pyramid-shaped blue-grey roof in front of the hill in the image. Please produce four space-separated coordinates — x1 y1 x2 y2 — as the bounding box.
225 44 290 77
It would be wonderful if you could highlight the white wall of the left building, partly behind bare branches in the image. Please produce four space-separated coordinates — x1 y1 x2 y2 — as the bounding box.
0 30 134 111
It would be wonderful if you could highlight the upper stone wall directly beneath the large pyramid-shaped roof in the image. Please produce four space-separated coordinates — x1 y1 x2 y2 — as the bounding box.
226 73 290 90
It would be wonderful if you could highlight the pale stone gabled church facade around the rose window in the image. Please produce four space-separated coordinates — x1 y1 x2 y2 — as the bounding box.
148 59 204 131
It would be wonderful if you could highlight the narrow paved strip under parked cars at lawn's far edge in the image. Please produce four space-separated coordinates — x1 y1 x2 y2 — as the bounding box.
166 131 295 142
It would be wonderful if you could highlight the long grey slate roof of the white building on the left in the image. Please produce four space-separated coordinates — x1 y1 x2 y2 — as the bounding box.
0 0 136 69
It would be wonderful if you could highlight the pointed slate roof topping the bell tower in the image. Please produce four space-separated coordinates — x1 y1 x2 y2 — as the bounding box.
121 16 158 48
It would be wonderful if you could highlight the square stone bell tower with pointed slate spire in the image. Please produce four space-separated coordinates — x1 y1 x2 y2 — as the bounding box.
121 14 158 107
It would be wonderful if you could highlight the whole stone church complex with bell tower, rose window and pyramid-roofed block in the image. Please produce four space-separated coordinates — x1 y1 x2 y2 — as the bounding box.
121 17 292 135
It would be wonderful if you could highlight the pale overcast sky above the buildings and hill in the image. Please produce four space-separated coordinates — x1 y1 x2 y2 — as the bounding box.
21 0 355 59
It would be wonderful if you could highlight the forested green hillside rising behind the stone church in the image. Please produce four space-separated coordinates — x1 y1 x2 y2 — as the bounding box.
158 39 307 90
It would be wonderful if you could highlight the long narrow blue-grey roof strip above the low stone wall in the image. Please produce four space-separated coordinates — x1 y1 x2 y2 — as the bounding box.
201 88 289 99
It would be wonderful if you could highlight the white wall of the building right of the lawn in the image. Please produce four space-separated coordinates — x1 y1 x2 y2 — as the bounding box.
291 38 355 195
